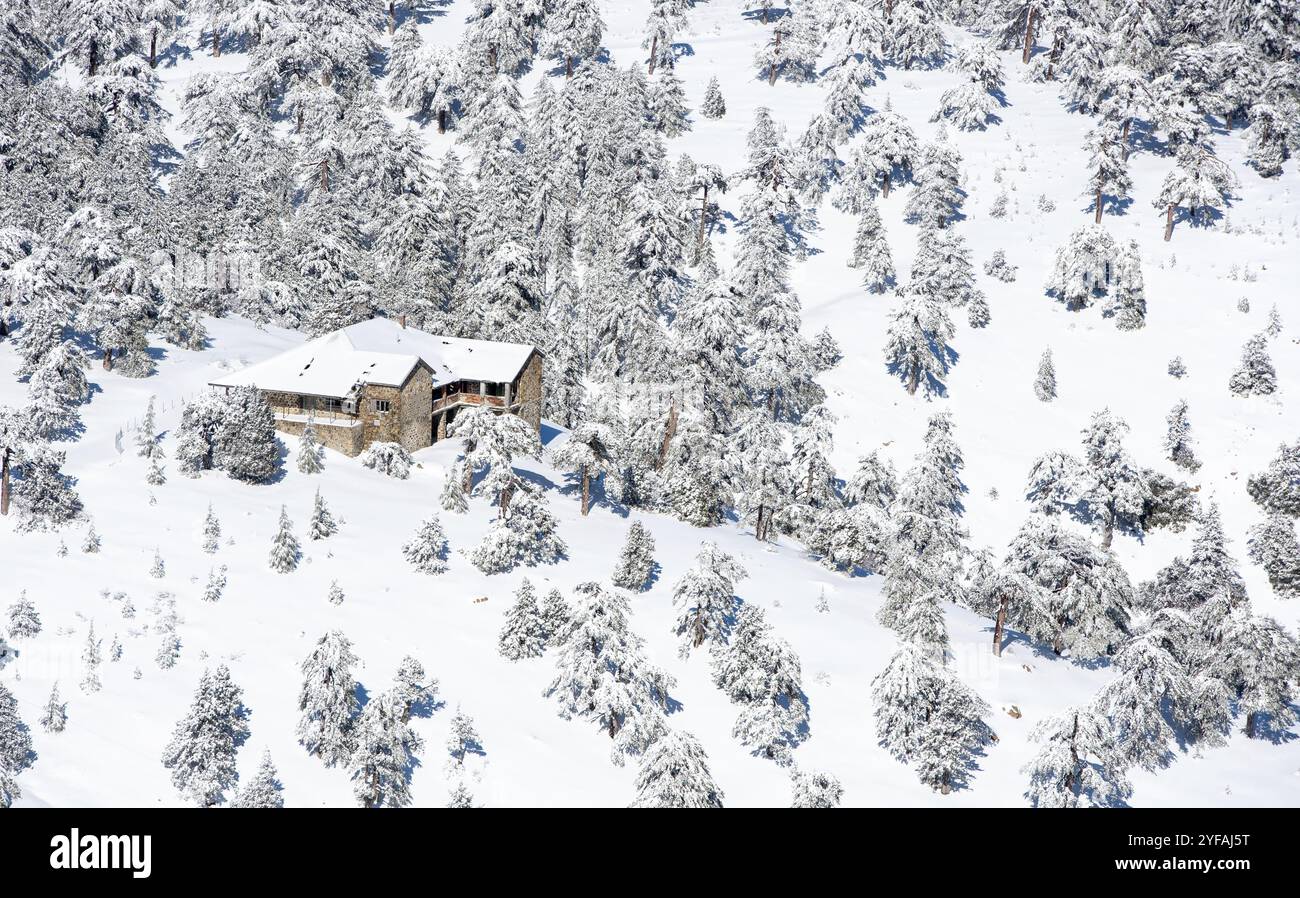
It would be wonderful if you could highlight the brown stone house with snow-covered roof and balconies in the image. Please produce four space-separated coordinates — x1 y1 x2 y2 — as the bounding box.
211 318 542 455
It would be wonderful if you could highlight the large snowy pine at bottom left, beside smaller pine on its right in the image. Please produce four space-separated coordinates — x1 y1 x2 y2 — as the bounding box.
163 664 248 807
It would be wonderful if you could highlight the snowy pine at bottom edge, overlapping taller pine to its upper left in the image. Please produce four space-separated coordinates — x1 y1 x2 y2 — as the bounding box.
348 693 424 807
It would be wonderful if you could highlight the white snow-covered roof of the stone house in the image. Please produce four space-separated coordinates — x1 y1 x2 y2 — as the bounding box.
211 318 533 398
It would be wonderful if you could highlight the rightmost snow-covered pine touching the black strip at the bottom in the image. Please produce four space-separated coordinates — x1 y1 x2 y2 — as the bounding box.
1023 707 1132 807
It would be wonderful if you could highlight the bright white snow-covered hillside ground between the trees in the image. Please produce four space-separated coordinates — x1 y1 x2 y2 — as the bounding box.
0 0 1300 806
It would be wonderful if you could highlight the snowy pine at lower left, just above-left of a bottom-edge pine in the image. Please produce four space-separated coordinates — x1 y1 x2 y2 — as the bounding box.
298 630 358 767
